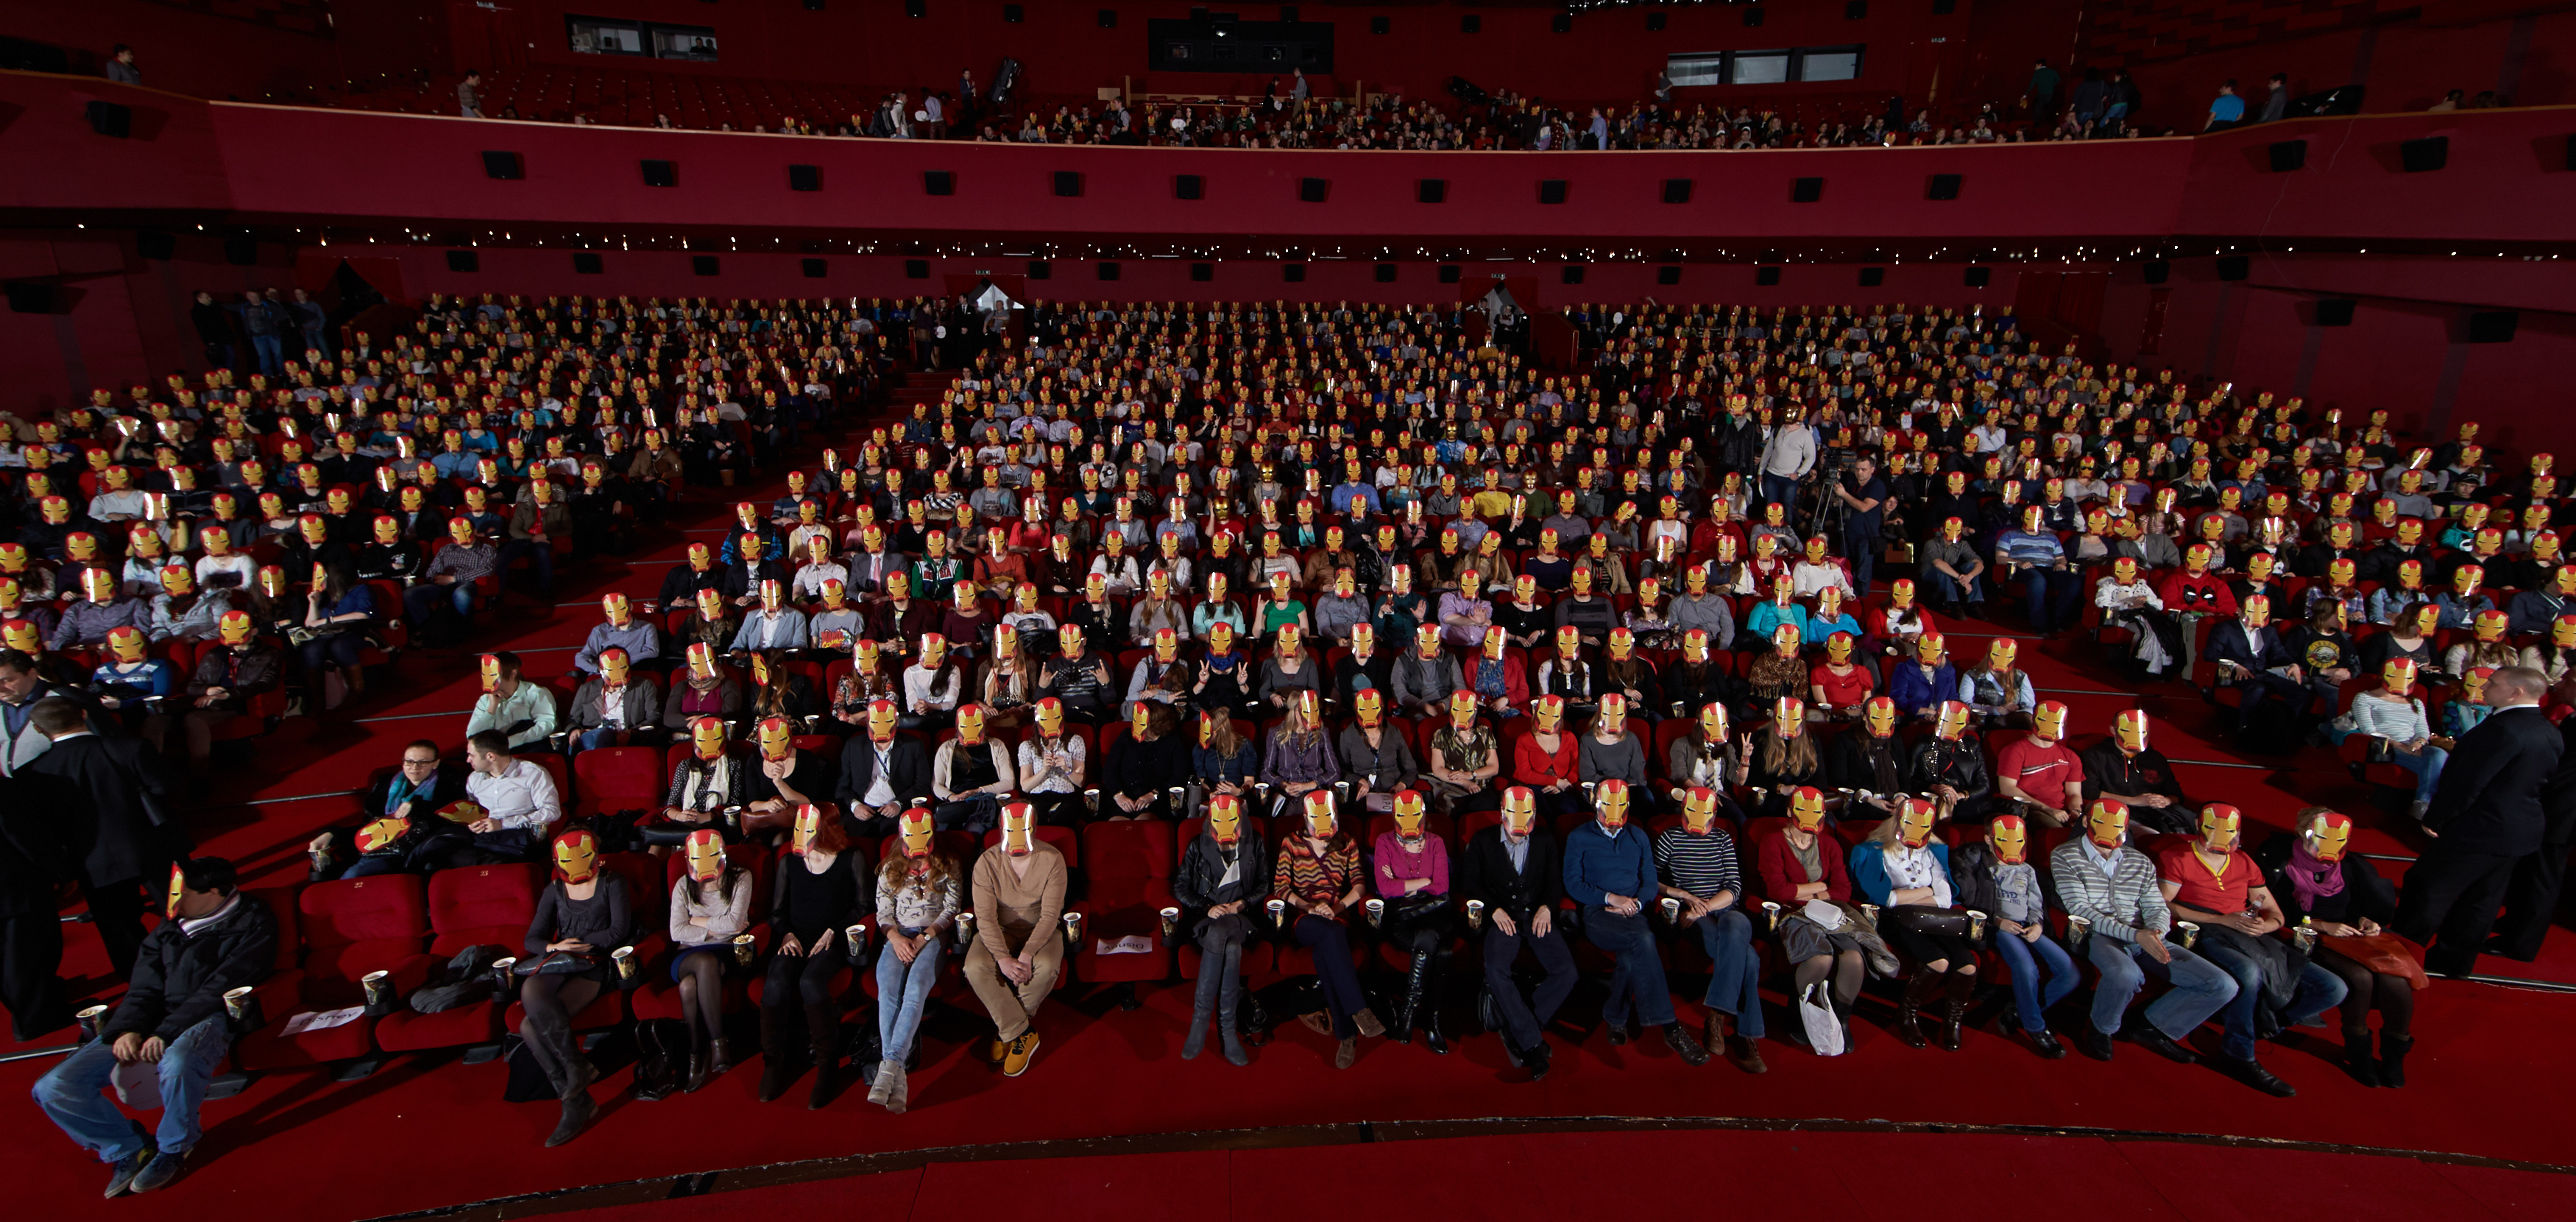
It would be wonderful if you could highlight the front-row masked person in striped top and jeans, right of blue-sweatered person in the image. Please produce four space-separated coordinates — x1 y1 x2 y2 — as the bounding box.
1654 789 1767 1073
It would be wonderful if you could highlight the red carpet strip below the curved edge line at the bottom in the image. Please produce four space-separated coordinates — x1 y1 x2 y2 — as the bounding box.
556 1131 2576 1222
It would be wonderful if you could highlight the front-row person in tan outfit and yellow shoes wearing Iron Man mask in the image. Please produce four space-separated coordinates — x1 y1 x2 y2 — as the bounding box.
966 802 1066 1078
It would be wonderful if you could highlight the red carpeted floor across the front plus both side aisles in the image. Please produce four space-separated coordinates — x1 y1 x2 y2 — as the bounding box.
0 394 2576 1222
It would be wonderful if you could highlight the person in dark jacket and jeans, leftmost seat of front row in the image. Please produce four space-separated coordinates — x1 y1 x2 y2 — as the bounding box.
36 856 278 1196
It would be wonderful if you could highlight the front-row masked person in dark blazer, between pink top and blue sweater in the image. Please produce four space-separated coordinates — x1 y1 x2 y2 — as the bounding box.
1458 786 1574 1083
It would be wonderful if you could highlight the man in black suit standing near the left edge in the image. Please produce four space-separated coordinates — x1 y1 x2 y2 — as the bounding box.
18 696 188 977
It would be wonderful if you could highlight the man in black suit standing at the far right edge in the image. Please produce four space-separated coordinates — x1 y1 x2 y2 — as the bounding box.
2396 665 2563 977
